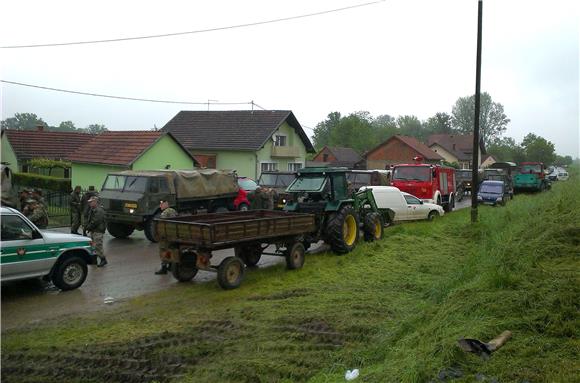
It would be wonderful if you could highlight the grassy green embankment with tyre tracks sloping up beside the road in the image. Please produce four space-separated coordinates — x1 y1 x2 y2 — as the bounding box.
2 174 580 382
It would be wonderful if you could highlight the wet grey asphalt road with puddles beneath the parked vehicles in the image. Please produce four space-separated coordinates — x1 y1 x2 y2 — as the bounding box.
1 201 471 331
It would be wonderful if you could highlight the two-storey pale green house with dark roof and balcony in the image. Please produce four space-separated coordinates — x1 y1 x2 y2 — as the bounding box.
162 111 315 179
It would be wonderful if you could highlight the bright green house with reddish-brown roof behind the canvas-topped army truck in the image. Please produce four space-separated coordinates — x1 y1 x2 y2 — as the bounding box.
67 131 198 190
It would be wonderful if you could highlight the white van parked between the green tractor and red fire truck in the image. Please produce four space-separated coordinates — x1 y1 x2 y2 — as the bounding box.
361 186 444 222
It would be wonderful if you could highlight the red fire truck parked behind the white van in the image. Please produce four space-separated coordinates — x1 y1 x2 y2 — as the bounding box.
391 157 455 211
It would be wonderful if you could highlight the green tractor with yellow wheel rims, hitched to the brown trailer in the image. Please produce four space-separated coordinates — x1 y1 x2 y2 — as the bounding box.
284 168 395 254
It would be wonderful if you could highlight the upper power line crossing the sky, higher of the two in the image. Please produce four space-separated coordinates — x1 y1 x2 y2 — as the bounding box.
0 0 386 49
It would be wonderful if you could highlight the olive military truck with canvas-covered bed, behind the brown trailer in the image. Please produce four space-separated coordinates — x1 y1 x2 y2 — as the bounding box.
100 169 249 242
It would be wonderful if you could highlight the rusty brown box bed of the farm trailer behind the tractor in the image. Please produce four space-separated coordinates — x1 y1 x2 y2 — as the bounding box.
156 210 316 250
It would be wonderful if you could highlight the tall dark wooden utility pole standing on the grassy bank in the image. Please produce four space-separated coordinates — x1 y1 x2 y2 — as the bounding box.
471 0 483 223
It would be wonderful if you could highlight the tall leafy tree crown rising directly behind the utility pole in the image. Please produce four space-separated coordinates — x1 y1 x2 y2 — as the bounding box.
451 92 510 147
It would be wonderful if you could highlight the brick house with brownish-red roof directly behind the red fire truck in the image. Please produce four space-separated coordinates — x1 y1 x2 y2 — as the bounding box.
363 135 444 169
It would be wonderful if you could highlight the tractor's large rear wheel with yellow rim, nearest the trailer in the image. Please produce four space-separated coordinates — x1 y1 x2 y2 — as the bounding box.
326 205 358 254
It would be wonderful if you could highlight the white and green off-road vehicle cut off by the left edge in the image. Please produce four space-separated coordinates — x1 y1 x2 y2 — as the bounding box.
0 207 97 290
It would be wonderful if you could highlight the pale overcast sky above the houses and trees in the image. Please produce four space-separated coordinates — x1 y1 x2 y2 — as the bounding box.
0 0 580 157
